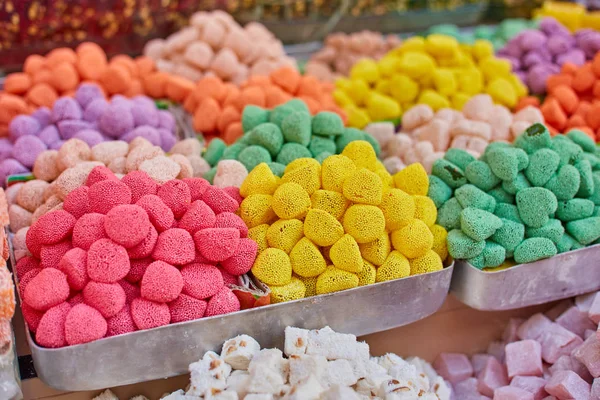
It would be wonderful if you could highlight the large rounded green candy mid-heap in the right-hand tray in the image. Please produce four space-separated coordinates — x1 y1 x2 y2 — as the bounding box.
516 187 558 228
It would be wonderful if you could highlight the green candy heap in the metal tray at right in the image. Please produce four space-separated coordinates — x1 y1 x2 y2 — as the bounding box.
428 124 600 268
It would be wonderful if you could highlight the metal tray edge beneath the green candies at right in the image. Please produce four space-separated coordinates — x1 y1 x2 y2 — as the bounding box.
450 245 600 311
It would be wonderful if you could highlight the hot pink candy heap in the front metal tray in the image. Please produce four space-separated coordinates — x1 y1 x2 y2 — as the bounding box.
16 167 257 347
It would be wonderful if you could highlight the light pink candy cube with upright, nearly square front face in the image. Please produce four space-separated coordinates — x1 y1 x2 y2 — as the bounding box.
505 339 543 378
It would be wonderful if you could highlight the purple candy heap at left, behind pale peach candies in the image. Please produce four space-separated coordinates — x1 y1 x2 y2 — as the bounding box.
0 83 177 185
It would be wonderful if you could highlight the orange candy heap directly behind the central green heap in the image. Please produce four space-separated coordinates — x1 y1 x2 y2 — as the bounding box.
184 67 344 144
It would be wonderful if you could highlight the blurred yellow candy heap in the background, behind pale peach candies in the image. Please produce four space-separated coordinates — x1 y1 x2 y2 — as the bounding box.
334 34 527 128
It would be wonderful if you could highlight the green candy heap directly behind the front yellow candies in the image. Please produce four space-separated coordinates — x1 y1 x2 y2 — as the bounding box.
203 99 381 182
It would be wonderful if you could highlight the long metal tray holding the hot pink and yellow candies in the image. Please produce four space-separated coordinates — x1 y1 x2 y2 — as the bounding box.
27 265 453 391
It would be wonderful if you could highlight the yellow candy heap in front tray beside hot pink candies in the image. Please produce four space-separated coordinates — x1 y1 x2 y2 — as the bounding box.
239 141 448 303
